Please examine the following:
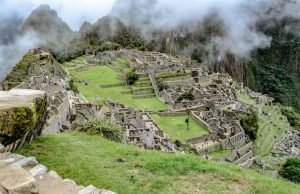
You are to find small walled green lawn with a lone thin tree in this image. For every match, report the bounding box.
[152,114,208,142]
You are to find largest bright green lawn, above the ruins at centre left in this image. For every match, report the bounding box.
[70,66,166,110]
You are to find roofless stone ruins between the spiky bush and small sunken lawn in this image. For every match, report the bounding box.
[105,99,175,152]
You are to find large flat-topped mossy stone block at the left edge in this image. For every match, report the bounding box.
[0,89,47,150]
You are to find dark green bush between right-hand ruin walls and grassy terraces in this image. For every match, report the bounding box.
[237,109,258,140]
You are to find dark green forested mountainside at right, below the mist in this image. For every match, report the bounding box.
[246,19,300,112]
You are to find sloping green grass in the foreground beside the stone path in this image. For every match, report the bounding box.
[18,132,300,194]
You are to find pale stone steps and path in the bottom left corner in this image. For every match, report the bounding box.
[0,150,115,194]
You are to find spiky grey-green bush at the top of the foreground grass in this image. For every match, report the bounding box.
[76,119,123,141]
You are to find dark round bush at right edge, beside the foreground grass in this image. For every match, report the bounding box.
[280,158,300,183]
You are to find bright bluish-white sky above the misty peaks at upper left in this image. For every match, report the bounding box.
[0,0,115,30]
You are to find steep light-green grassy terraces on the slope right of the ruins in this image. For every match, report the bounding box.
[237,91,290,156]
